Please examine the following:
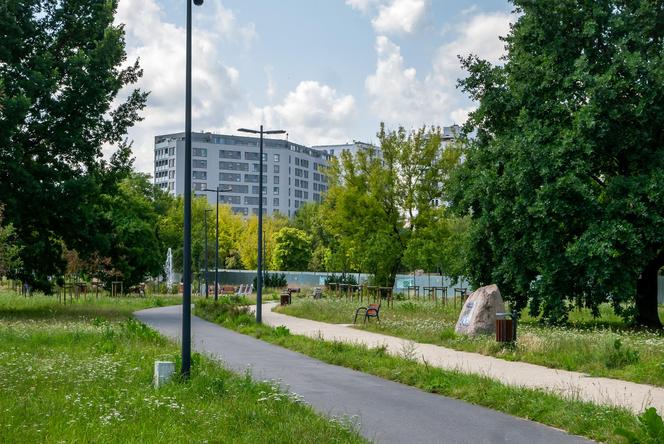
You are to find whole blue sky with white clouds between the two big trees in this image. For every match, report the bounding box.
[114,0,514,172]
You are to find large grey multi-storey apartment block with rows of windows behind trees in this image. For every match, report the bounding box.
[154,133,331,216]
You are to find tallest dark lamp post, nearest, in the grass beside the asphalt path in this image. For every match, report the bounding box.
[181,0,203,378]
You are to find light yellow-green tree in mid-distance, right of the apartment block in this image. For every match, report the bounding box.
[323,125,459,286]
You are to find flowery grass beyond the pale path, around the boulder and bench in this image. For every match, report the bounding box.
[276,298,664,386]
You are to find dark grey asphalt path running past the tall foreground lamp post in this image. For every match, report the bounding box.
[135,306,590,444]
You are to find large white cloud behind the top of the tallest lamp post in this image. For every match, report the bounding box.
[111,0,256,172]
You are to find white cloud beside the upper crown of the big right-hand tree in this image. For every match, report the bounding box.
[365,13,514,127]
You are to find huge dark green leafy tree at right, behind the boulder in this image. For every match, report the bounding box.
[452,0,664,328]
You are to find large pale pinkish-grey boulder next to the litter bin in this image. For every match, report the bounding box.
[454,284,505,336]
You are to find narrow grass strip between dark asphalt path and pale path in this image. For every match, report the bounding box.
[195,302,639,443]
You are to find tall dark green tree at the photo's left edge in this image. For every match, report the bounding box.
[0,0,146,290]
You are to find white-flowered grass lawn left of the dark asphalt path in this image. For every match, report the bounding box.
[0,293,365,443]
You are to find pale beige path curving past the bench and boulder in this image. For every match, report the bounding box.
[263,304,664,414]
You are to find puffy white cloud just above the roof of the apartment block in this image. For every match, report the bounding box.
[223,80,355,145]
